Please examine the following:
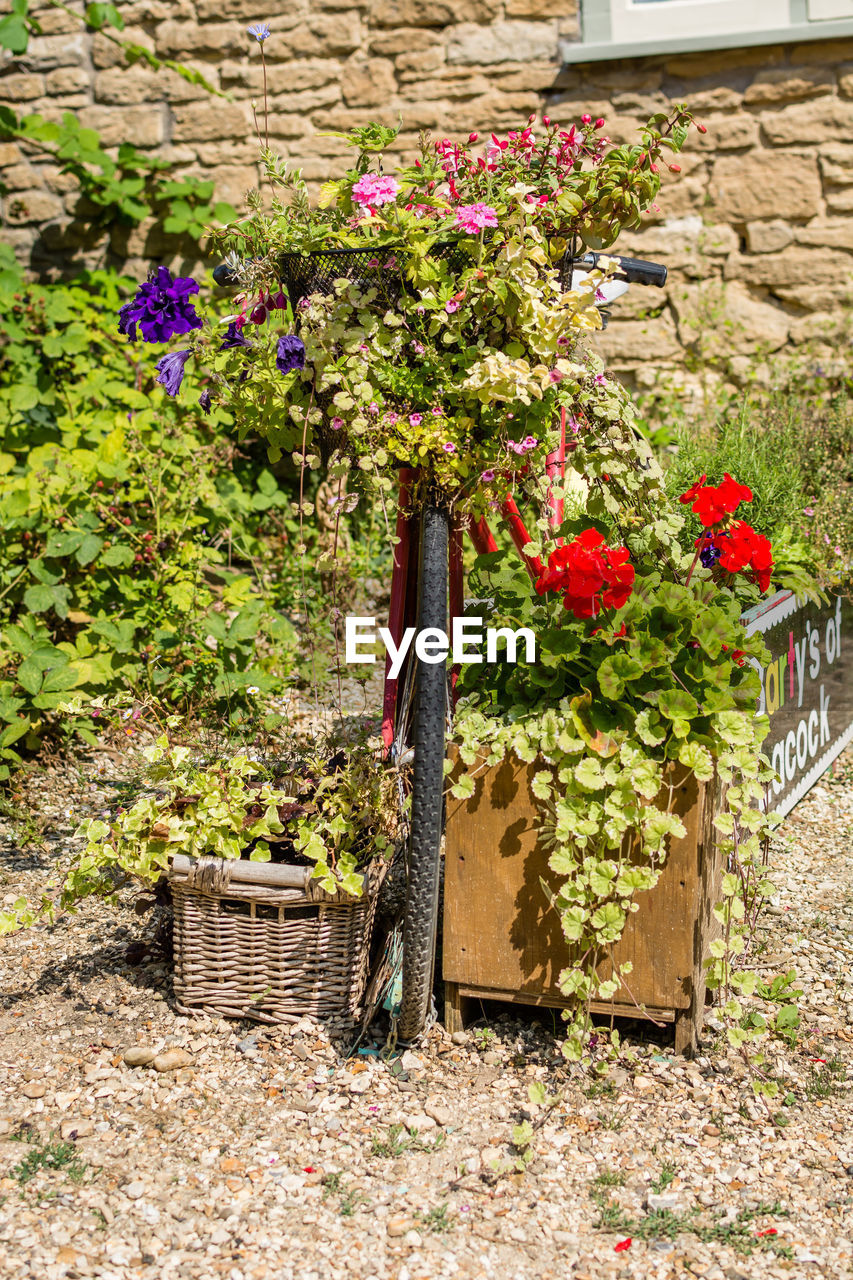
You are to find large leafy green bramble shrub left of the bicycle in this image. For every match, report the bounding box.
[0,245,297,778]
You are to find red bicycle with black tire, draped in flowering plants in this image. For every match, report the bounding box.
[213,243,667,1043]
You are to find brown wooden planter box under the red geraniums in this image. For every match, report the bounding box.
[443,759,720,1053]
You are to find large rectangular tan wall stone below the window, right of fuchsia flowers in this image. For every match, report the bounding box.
[710,152,821,223]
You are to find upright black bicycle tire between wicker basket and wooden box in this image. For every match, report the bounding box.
[397,503,450,1043]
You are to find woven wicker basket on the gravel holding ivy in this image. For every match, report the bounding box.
[169,856,386,1023]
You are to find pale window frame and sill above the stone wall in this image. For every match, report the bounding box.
[561,0,853,63]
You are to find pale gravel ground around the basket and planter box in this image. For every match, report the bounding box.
[0,753,853,1280]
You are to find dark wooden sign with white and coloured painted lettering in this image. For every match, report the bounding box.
[743,591,853,814]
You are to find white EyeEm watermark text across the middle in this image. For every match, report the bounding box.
[345,616,537,680]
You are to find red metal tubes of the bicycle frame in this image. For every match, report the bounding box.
[382,408,563,751]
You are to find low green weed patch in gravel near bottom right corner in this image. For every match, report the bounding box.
[590,1190,794,1258]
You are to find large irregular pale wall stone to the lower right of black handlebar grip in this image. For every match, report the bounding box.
[670,280,790,357]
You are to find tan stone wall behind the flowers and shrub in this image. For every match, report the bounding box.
[0,0,853,384]
